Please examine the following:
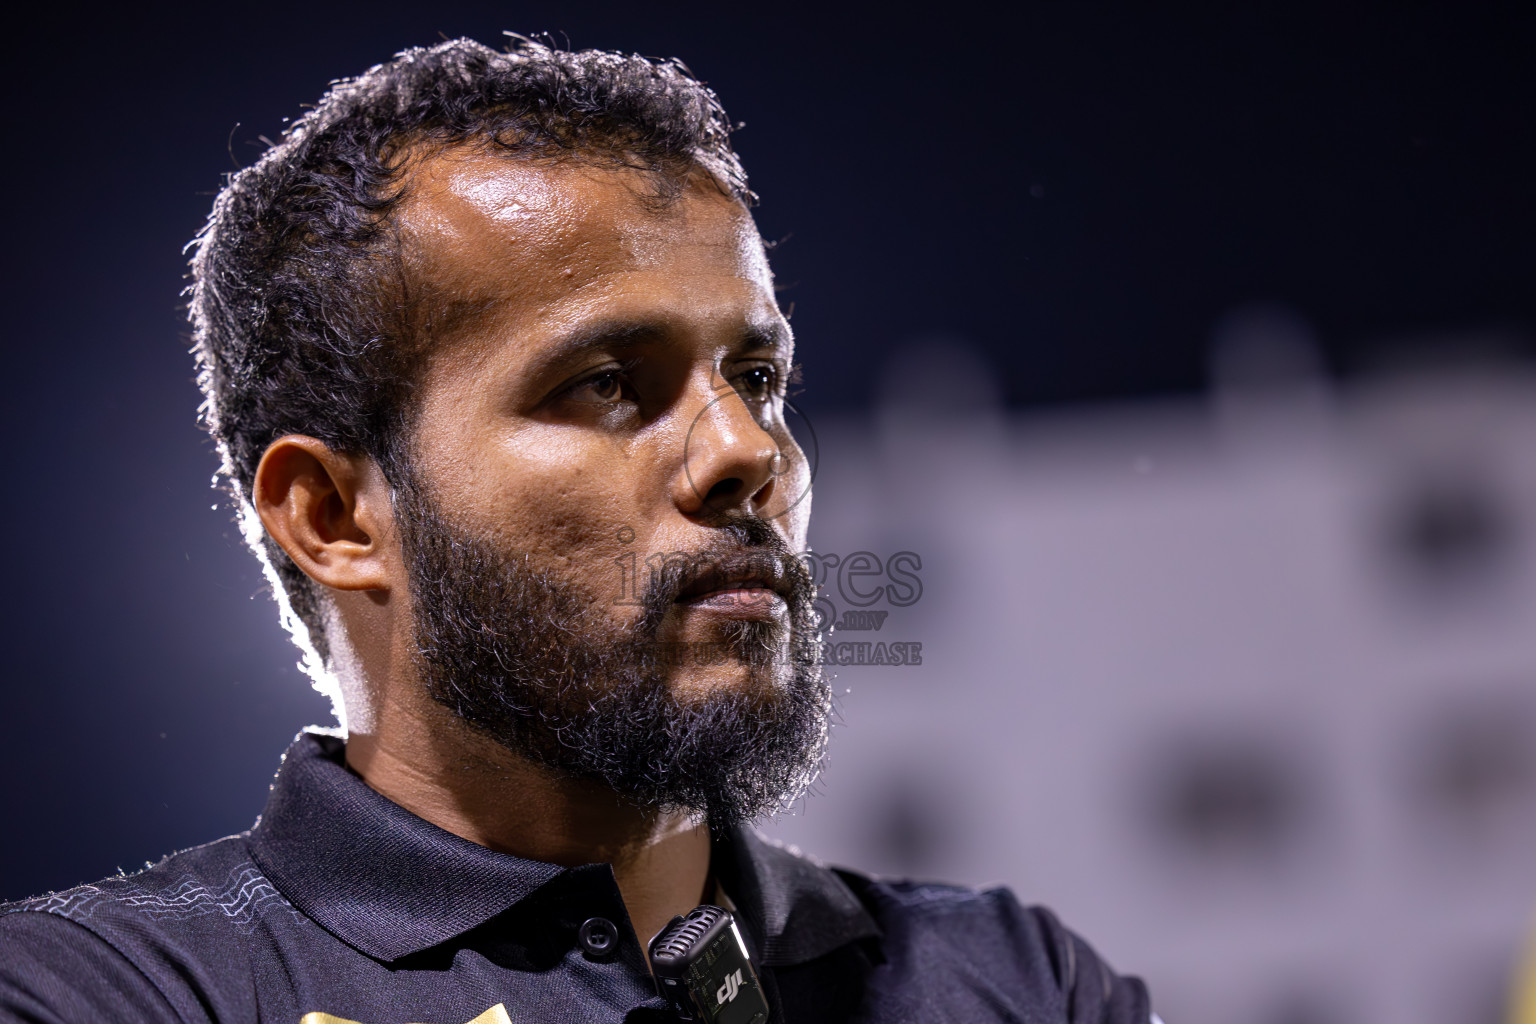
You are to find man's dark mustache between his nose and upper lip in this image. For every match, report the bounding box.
[634,514,816,640]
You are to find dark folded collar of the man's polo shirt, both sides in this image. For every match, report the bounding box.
[250,732,880,966]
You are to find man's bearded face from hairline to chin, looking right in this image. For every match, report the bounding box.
[396,150,826,818]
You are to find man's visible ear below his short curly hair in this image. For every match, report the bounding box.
[250,434,395,591]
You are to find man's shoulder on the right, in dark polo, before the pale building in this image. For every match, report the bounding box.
[837,869,1152,1024]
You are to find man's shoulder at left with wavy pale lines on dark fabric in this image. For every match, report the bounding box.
[0,835,293,1021]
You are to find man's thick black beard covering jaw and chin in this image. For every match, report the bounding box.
[396,484,833,829]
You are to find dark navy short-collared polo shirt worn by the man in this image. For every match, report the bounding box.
[0,734,1150,1024]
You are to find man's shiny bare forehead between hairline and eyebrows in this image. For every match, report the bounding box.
[396,147,773,340]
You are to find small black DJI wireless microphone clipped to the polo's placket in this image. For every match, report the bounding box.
[650,903,768,1024]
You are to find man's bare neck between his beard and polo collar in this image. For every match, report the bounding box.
[347,699,710,947]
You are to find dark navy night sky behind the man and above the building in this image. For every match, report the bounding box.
[0,0,1536,898]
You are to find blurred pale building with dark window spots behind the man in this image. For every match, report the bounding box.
[770,340,1536,1024]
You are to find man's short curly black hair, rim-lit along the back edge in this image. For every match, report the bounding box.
[189,34,754,697]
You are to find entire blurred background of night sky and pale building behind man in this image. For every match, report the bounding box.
[0,0,1536,1024]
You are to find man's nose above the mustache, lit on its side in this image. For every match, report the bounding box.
[673,380,791,516]
